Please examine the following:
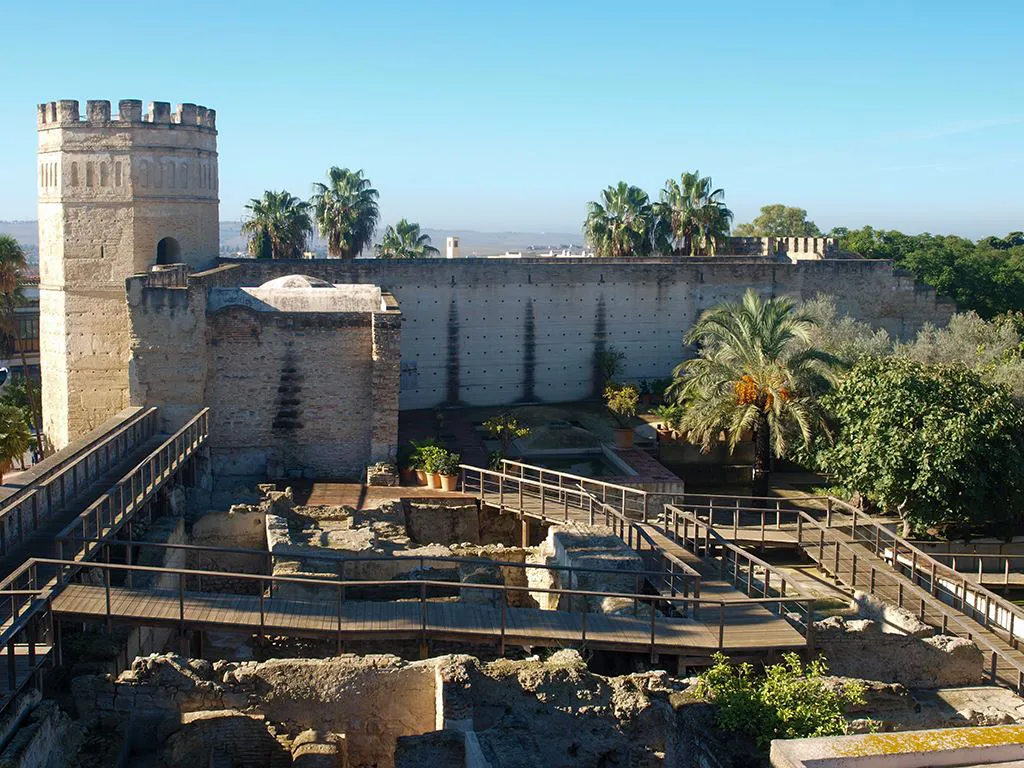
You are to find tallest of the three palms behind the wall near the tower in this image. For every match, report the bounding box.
[310,166,380,259]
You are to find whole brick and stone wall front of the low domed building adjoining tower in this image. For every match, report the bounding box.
[127,275,401,480]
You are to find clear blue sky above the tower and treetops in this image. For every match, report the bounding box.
[0,0,1024,237]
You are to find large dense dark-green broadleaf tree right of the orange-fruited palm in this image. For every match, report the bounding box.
[817,357,1024,534]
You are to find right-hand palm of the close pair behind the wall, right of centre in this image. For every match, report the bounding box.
[656,171,732,256]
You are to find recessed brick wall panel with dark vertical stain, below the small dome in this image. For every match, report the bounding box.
[206,307,374,478]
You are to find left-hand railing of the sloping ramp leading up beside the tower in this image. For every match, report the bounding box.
[0,408,159,556]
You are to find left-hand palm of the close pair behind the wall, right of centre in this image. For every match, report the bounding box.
[584,181,664,258]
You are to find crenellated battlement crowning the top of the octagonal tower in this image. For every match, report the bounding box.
[37,98,217,131]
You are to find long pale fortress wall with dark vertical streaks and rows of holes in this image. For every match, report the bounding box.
[209,257,954,410]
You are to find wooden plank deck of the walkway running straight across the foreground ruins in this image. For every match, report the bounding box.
[52,584,806,656]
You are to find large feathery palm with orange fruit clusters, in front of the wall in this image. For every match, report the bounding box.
[672,290,839,494]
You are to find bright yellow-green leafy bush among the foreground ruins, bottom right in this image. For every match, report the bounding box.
[697,653,864,751]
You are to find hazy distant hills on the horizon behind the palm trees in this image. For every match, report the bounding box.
[0,221,583,261]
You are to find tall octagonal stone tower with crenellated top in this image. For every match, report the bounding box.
[38,99,220,449]
